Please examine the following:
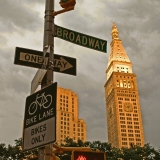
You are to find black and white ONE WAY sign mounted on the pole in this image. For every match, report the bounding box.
[14,47,76,75]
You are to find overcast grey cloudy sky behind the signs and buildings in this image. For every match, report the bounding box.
[0,0,160,148]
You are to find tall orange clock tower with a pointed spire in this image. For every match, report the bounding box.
[105,23,144,148]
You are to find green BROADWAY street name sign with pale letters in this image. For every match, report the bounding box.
[55,25,107,53]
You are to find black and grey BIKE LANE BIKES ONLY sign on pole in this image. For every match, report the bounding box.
[23,83,57,151]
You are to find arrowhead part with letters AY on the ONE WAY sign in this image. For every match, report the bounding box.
[54,57,73,72]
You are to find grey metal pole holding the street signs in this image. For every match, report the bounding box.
[38,0,54,160]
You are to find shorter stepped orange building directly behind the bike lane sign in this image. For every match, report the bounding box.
[56,87,86,144]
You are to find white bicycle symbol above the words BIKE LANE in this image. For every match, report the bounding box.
[28,92,52,115]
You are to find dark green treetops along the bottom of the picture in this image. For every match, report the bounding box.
[0,137,160,160]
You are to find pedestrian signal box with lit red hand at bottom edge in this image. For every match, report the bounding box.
[72,151,106,160]
